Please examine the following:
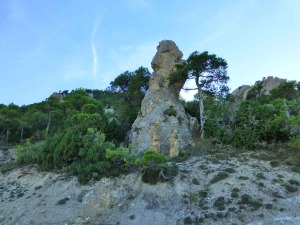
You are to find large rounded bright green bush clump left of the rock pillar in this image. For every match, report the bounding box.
[34,125,135,183]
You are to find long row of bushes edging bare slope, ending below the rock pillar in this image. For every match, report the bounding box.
[17,134,177,184]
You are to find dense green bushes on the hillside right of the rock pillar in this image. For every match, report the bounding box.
[183,81,300,149]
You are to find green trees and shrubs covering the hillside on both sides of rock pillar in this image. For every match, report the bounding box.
[0,67,300,183]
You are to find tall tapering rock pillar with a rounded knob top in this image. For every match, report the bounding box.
[129,40,198,157]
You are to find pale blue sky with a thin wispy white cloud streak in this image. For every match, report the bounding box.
[0,0,300,105]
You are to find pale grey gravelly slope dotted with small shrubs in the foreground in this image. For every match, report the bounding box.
[0,148,300,225]
